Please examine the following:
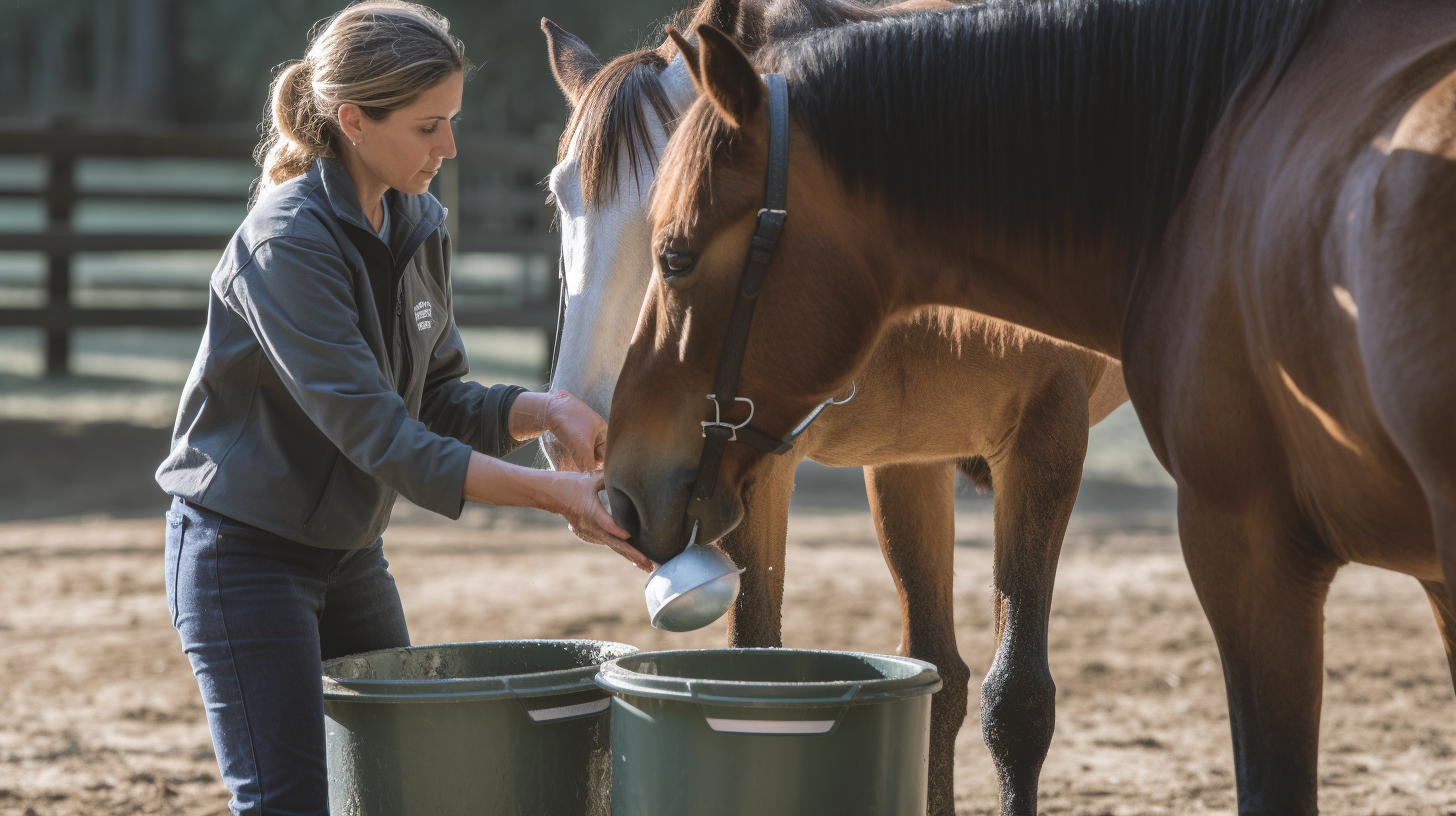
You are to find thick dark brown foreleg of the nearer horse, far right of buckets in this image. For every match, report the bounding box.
[1178,490,1340,816]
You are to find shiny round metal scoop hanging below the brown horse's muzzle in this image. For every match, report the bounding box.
[646,522,743,632]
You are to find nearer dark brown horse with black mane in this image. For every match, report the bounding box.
[607,0,1456,815]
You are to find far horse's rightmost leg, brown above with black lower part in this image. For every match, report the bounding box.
[981,408,1086,816]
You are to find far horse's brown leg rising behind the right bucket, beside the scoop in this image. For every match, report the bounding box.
[719,456,799,647]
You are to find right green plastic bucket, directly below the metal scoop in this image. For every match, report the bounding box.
[597,648,941,816]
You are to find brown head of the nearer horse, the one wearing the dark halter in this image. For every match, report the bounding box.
[607,26,885,561]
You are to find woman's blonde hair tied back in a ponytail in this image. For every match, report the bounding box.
[253,0,470,201]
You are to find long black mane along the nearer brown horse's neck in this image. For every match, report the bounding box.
[759,0,1326,246]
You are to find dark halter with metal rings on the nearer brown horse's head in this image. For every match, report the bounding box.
[693,74,855,501]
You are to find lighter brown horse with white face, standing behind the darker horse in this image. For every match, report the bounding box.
[546,0,1127,815]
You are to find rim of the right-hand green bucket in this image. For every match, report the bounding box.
[597,647,942,708]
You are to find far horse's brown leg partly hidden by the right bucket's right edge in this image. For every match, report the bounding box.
[865,462,971,816]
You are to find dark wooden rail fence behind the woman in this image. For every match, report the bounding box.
[0,127,559,376]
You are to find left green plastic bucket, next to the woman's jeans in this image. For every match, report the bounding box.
[323,640,636,816]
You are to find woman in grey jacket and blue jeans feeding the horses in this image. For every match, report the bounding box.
[157,0,649,815]
